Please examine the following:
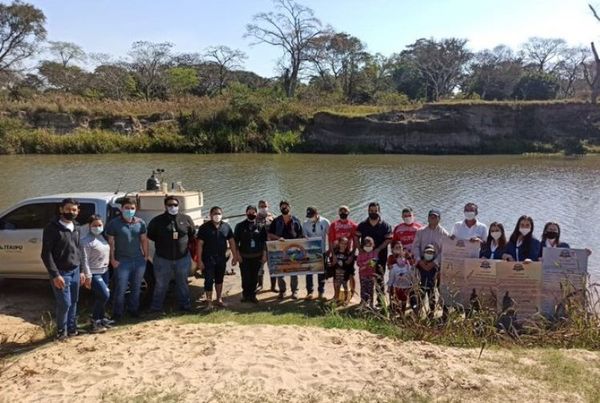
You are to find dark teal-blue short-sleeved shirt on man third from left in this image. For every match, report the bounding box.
[105,217,146,260]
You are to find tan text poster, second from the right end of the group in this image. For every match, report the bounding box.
[496,261,542,319]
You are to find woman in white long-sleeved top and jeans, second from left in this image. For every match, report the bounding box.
[81,215,112,333]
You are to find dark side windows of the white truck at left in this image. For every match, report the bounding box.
[0,203,96,230]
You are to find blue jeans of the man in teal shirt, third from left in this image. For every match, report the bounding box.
[113,257,146,319]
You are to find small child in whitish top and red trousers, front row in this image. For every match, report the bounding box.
[387,241,415,317]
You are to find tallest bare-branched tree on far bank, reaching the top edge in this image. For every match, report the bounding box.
[244,0,325,97]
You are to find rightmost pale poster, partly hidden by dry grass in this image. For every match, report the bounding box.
[541,248,588,317]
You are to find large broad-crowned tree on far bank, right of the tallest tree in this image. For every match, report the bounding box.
[401,38,472,101]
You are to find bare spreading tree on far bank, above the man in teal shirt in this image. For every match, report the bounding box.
[129,41,173,100]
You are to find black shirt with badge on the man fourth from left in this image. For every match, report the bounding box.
[148,213,196,260]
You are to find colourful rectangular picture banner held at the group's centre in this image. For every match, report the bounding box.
[267,237,325,277]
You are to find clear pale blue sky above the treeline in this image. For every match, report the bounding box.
[26,0,600,77]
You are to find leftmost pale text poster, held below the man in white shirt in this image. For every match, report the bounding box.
[440,238,479,305]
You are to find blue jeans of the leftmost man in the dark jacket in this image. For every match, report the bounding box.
[50,267,80,335]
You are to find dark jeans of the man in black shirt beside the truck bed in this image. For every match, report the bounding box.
[150,253,192,311]
